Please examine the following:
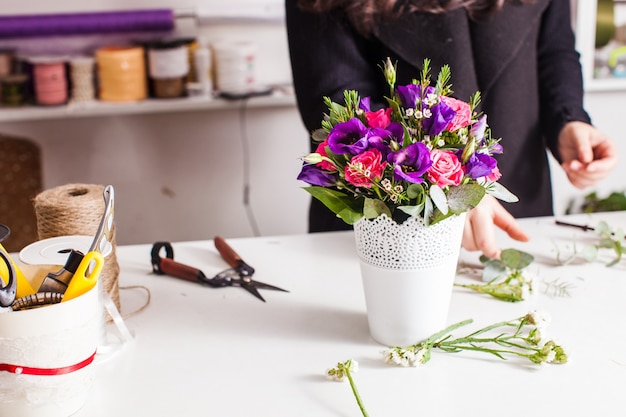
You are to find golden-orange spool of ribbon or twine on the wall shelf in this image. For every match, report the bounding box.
[96,46,147,102]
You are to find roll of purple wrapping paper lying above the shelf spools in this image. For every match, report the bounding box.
[0,9,174,39]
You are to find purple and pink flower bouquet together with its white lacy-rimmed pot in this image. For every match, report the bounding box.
[298,59,517,346]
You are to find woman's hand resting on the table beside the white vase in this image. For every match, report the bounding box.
[462,195,529,259]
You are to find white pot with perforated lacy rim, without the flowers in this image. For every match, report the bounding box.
[354,213,466,346]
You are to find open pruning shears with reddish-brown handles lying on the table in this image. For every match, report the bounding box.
[152,236,289,302]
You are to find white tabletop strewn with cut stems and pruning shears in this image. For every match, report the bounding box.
[77,212,626,417]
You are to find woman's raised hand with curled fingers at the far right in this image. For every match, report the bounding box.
[558,122,617,189]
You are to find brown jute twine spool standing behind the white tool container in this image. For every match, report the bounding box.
[34,184,121,310]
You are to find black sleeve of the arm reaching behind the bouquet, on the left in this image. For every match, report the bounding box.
[285,0,382,145]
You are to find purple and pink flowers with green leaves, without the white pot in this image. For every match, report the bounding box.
[298,58,517,225]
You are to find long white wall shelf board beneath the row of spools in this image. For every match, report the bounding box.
[0,93,296,123]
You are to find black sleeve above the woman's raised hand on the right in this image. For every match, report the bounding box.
[537,0,591,162]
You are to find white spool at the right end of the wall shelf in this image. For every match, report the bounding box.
[213,42,256,92]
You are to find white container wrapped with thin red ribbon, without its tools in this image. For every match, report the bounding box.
[0,276,104,417]
